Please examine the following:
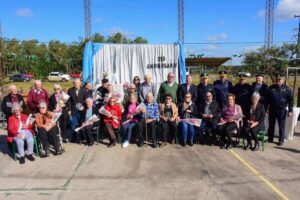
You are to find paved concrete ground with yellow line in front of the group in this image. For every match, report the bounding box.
[0,123,300,200]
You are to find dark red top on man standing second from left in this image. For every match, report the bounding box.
[27,88,49,112]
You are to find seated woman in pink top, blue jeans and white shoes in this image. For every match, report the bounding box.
[122,94,141,148]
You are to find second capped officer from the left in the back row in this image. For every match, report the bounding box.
[214,70,233,109]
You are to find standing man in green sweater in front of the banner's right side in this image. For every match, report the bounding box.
[157,72,178,104]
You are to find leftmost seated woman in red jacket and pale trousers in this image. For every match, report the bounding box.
[7,103,35,164]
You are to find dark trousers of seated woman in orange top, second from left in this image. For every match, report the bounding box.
[38,126,59,151]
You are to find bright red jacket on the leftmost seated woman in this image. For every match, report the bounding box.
[7,113,34,142]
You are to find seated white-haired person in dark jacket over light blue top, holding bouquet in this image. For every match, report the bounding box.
[81,98,99,146]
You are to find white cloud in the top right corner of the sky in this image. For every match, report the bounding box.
[275,0,300,21]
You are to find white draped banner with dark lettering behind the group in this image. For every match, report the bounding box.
[93,44,179,90]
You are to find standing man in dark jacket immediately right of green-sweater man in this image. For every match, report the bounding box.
[178,74,197,103]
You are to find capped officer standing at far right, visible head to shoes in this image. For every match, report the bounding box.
[267,74,294,146]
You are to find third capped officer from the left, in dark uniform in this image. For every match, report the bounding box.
[233,74,252,118]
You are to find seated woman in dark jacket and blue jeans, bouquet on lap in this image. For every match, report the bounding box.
[177,92,198,147]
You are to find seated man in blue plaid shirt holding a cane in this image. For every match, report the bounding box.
[138,92,159,148]
